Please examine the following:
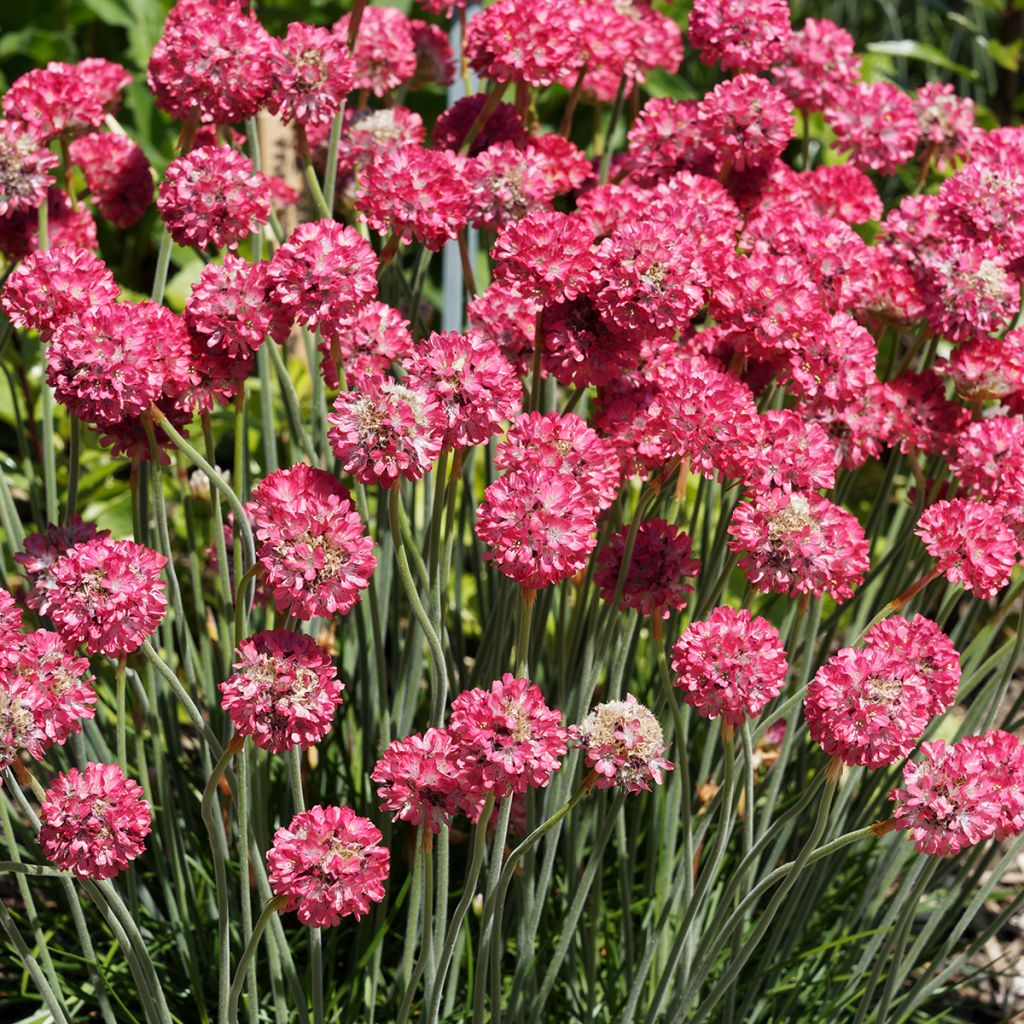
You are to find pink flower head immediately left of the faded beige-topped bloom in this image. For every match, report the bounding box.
[449,672,568,797]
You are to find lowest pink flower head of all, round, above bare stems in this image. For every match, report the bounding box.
[266,806,391,928]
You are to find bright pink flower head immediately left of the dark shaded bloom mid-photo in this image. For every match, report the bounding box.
[476,469,597,590]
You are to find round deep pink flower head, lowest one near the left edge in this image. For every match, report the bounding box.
[39,761,153,879]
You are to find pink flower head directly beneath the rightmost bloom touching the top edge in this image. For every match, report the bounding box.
[696,75,794,171]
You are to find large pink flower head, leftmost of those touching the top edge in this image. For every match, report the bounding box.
[146,2,274,125]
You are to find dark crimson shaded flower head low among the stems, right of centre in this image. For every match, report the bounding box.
[594,519,700,618]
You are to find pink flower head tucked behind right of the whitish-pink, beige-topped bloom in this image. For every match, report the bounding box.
[403,332,522,449]
